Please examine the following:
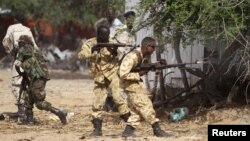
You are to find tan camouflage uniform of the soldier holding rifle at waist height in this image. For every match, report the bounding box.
[119,48,159,128]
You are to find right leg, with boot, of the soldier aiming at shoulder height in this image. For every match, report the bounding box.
[109,74,130,118]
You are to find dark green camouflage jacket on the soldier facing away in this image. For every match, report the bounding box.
[17,44,49,82]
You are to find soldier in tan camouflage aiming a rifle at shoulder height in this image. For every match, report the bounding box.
[78,25,130,136]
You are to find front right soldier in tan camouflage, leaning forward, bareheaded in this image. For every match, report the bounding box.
[119,37,169,137]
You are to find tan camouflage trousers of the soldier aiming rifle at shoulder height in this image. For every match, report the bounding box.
[92,73,130,119]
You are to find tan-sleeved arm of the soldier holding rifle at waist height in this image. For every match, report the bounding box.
[119,53,140,81]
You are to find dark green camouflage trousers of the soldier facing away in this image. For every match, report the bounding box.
[25,79,52,111]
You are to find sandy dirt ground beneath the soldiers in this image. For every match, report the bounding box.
[0,70,250,141]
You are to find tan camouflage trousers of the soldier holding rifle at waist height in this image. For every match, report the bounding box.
[123,81,159,128]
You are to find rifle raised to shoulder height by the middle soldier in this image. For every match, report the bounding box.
[91,43,139,52]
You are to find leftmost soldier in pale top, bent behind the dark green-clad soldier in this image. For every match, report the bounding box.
[2,15,38,117]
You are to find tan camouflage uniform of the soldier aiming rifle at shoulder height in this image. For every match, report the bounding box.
[78,38,129,119]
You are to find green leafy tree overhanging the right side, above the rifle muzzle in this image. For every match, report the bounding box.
[138,0,250,104]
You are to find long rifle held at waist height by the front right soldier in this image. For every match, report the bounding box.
[131,61,203,72]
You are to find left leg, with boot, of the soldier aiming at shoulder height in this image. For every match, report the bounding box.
[91,82,107,136]
